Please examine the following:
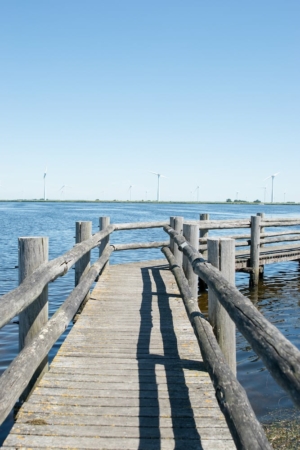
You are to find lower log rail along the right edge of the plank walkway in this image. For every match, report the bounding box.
[162,247,272,450]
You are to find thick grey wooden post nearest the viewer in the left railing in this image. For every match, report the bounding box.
[19,237,48,402]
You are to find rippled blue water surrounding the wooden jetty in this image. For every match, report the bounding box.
[0,202,300,445]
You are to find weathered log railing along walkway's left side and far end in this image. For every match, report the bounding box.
[0,217,168,424]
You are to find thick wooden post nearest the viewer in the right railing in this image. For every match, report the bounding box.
[207,238,236,374]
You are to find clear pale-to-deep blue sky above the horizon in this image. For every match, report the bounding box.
[0,0,300,201]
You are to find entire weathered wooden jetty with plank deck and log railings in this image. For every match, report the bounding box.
[0,214,300,450]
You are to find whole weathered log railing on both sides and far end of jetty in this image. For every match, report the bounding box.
[0,216,300,450]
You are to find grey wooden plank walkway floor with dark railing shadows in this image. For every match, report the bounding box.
[3,260,236,450]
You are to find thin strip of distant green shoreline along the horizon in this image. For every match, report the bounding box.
[0,199,300,206]
